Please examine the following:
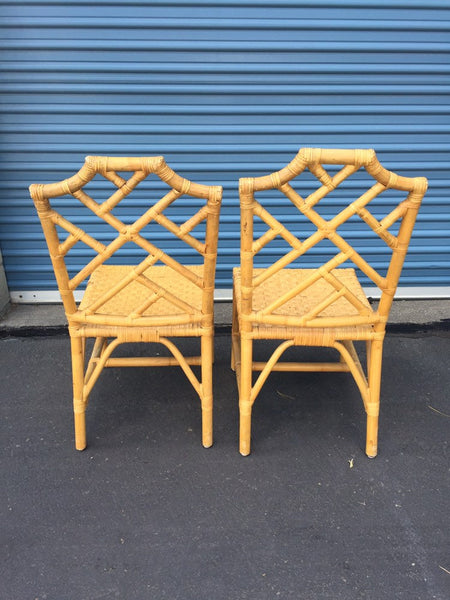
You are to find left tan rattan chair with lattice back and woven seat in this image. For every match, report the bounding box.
[30,156,222,450]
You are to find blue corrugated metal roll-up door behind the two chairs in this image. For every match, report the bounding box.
[0,0,450,300]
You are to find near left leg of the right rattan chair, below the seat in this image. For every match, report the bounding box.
[239,338,253,456]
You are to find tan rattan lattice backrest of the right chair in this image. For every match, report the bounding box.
[240,148,427,326]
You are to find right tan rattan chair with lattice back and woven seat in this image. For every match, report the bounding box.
[232,148,427,457]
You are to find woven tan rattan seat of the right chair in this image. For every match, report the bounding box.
[233,267,374,345]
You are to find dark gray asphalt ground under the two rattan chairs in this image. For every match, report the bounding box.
[0,332,450,600]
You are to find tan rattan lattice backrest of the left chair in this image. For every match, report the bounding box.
[30,156,222,324]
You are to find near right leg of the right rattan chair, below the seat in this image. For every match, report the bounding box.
[366,340,383,458]
